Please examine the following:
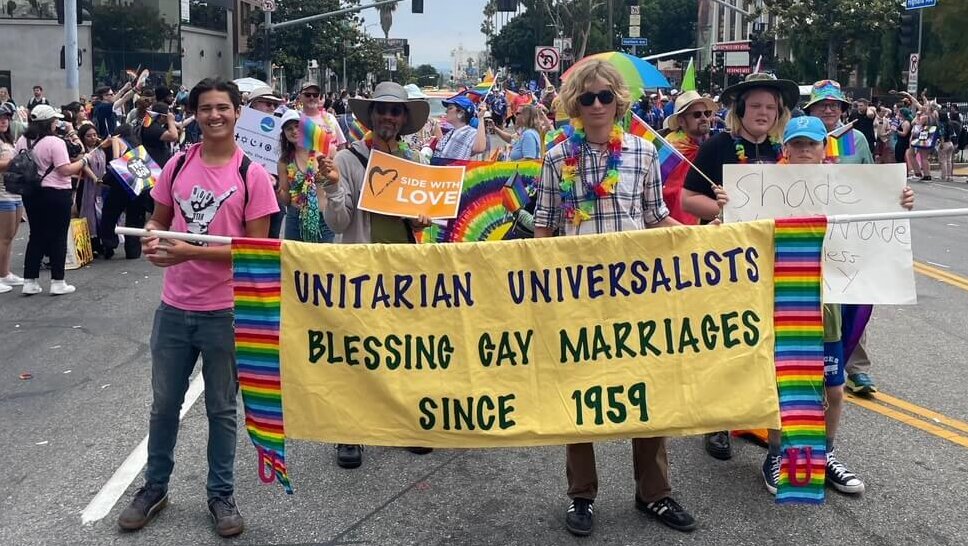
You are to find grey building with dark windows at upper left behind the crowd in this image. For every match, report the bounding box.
[0,0,241,105]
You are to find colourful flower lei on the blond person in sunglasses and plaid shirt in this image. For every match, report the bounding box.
[560,119,625,226]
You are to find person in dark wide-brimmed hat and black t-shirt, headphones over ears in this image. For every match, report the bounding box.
[682,73,800,460]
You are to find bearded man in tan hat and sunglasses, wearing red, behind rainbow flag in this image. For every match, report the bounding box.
[662,61,718,225]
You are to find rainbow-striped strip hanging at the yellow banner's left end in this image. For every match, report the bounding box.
[232,238,292,494]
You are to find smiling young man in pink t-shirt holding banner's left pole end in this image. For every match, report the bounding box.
[118,79,279,537]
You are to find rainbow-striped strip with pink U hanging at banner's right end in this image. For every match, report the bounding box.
[773,216,827,504]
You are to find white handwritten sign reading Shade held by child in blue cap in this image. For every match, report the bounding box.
[723,164,917,305]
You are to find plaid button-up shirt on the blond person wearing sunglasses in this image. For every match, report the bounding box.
[534,133,669,235]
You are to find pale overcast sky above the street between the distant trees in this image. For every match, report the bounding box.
[363,0,485,69]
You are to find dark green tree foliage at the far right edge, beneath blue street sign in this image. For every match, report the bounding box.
[919,2,968,97]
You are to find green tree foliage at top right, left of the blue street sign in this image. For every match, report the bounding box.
[763,0,901,79]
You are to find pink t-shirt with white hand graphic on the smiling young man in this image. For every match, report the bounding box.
[151,144,279,311]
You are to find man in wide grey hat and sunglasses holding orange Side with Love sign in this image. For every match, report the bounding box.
[323,82,431,468]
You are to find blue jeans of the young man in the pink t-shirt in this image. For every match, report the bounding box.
[145,303,239,498]
